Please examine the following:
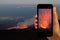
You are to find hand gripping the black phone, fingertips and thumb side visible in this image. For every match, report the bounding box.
[34,7,60,40]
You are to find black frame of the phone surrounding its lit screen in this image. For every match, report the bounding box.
[37,4,53,36]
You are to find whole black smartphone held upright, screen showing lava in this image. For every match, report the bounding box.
[37,4,53,36]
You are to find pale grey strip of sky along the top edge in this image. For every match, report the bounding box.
[0,0,60,4]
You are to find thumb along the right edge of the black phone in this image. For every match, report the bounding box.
[53,7,59,34]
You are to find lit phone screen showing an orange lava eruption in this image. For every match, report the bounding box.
[38,9,52,30]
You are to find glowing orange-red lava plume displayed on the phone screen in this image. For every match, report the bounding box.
[39,10,51,29]
